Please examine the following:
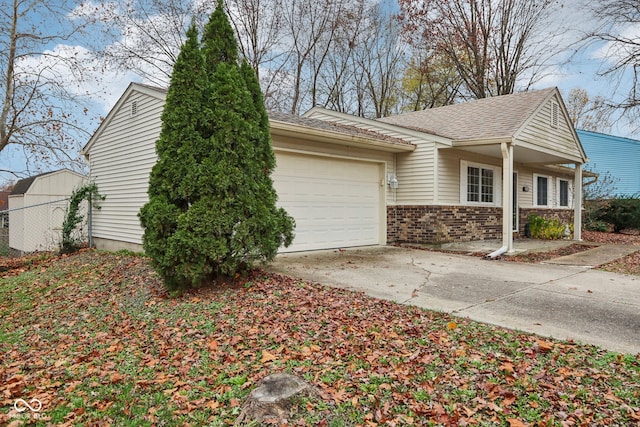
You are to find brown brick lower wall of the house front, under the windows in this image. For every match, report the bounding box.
[387,205,573,244]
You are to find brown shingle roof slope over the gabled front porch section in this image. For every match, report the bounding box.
[378,88,556,140]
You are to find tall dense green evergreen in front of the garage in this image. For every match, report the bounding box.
[140,1,293,290]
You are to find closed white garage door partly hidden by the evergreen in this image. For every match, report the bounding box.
[273,152,382,252]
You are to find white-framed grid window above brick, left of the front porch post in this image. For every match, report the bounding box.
[460,161,500,205]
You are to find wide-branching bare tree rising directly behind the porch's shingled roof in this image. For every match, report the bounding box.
[399,0,556,98]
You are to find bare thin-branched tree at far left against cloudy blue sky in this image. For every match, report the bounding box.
[0,0,95,177]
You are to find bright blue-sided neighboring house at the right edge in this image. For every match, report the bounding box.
[576,130,640,196]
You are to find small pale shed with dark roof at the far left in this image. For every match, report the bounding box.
[9,169,87,253]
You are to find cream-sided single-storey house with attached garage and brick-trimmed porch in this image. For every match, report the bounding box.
[83,83,587,251]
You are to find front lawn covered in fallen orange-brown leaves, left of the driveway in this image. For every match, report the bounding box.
[0,251,640,426]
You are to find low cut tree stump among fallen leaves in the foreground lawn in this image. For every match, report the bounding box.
[234,374,320,426]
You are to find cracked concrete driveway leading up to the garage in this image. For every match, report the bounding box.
[268,246,640,354]
